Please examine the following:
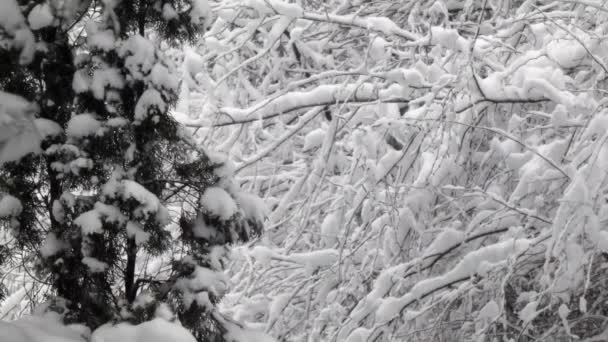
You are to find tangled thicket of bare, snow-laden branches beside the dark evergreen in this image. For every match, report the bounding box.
[181,0,608,341]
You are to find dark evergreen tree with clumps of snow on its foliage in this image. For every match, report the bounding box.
[0,0,262,341]
